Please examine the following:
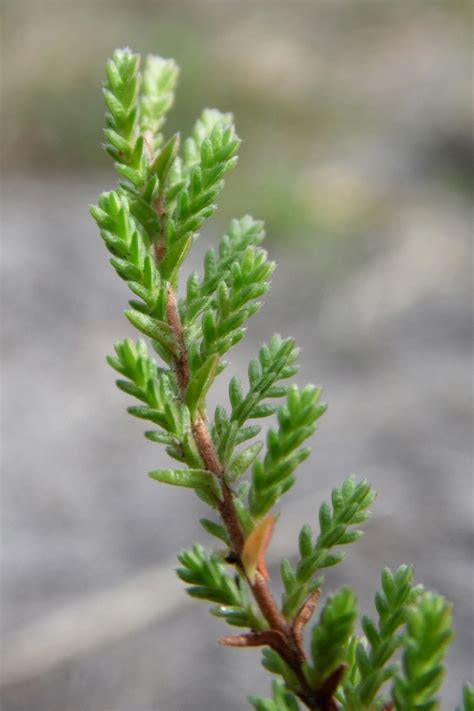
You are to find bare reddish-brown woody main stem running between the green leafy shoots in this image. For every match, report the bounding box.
[167,286,326,711]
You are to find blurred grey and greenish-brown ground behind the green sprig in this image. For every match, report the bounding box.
[1,0,474,711]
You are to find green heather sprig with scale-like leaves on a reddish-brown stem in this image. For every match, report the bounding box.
[91,49,474,711]
